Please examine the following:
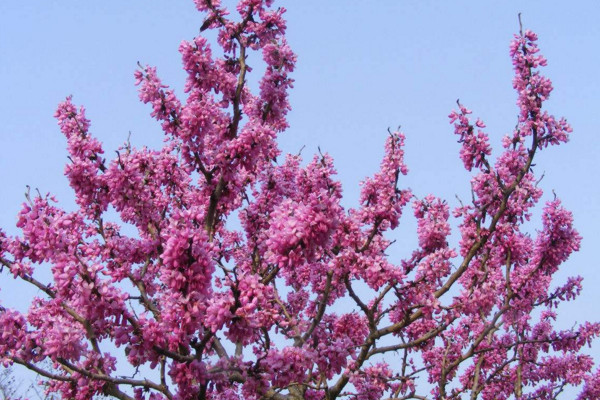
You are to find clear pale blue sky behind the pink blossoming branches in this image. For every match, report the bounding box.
[0,0,600,396]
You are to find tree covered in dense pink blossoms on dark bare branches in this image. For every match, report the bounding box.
[0,0,600,400]
